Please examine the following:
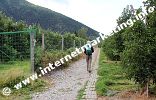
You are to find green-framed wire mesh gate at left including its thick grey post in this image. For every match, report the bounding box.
[0,31,35,71]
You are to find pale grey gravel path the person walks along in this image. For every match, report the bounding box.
[32,49,99,100]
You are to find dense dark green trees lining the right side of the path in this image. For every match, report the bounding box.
[102,0,156,90]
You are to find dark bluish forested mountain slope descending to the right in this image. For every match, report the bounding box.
[0,0,97,36]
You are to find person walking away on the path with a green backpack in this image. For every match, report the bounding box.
[84,41,94,73]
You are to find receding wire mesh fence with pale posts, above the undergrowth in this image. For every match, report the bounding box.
[40,33,86,51]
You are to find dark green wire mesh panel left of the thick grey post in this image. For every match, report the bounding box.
[0,33,30,63]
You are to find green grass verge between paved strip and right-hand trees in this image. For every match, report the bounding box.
[96,50,137,96]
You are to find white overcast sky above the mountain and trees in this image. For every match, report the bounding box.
[27,0,143,34]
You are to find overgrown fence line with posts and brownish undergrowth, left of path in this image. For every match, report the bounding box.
[35,31,87,71]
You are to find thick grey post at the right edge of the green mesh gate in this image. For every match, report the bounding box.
[30,31,35,73]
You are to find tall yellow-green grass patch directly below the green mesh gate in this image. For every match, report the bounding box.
[0,61,30,87]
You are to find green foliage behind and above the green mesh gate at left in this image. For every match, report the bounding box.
[0,12,30,62]
